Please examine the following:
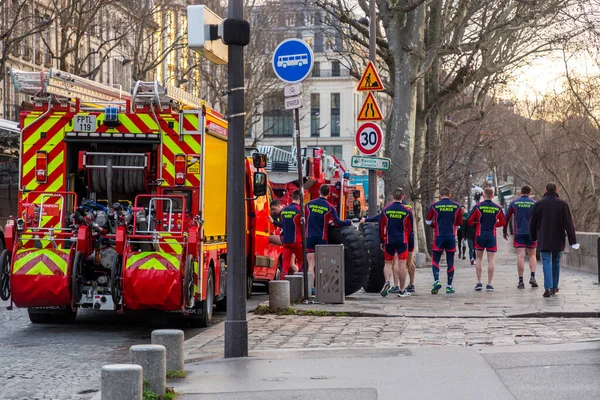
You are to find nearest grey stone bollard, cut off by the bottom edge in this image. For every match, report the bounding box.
[100,364,144,400]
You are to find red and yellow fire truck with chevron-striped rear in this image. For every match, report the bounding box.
[0,70,278,326]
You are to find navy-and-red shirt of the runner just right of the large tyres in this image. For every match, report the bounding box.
[365,201,414,244]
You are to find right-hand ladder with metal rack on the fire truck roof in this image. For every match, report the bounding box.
[131,81,202,112]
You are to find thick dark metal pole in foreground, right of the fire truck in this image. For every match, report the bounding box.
[225,0,248,358]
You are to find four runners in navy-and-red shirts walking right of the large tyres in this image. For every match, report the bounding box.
[360,186,538,297]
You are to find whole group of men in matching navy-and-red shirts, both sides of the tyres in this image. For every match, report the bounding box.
[271,185,538,297]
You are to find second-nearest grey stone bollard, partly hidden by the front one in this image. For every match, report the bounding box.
[129,344,167,396]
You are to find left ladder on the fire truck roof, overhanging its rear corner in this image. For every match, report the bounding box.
[9,68,131,103]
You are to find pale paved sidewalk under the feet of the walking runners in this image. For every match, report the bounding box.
[292,238,600,318]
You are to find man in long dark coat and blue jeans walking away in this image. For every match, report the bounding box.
[529,182,579,297]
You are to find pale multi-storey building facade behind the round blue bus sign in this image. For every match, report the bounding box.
[246,0,363,170]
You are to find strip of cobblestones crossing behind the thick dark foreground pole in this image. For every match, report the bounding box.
[186,315,600,362]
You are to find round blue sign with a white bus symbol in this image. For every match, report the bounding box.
[273,39,315,83]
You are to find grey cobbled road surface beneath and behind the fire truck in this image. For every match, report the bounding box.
[0,286,266,400]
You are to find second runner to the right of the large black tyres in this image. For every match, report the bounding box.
[425,188,462,294]
